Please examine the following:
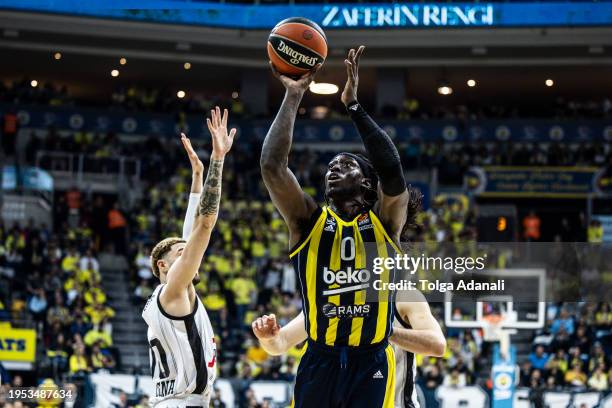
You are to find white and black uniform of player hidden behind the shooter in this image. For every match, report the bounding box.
[392,308,419,408]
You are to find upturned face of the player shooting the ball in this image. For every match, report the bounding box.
[325,155,364,199]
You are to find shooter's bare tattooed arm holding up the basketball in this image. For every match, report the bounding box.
[260,64,320,246]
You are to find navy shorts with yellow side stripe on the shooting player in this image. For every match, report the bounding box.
[292,341,395,408]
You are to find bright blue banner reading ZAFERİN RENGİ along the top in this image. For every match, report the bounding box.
[0,0,612,29]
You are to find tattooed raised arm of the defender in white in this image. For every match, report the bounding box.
[162,107,236,299]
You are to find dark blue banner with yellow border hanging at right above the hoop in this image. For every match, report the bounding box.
[465,166,612,198]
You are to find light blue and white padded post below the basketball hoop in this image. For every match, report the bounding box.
[491,344,516,408]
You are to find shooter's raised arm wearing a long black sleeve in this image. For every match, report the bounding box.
[341,45,410,242]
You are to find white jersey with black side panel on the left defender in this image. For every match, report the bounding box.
[142,284,217,405]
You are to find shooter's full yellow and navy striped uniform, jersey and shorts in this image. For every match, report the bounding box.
[290,207,400,408]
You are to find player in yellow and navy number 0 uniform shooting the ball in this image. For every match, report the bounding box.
[261,46,418,408]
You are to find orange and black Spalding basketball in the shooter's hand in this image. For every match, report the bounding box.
[268,17,327,77]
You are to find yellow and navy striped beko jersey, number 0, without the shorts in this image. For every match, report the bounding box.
[290,207,399,347]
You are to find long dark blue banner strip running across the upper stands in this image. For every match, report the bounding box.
[0,105,612,143]
